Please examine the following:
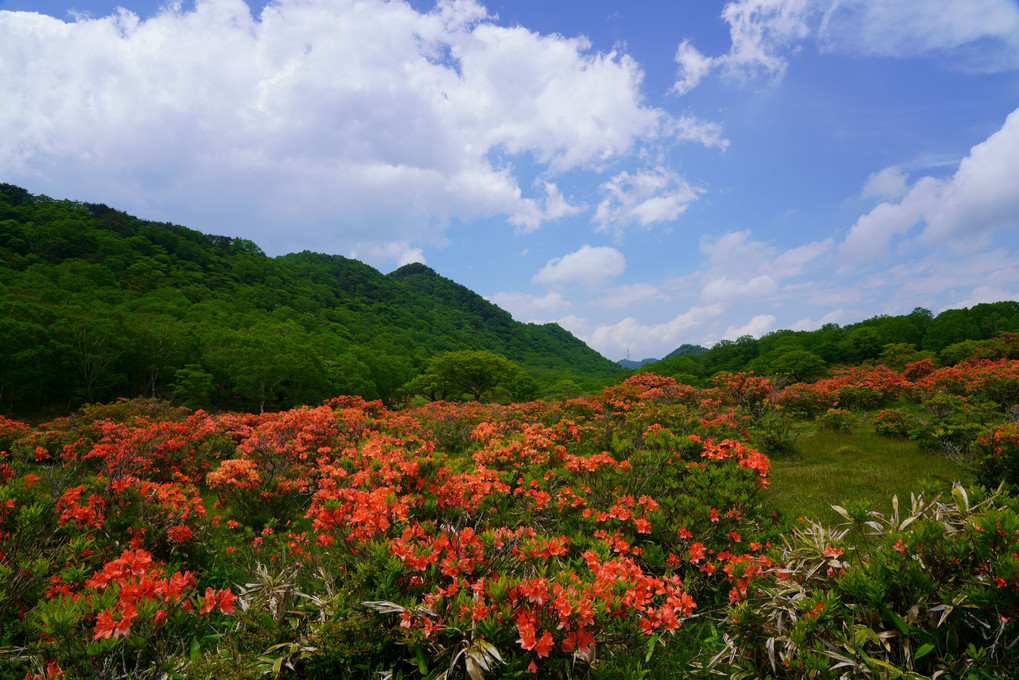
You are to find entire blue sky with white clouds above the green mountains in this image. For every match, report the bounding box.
[0,0,1019,360]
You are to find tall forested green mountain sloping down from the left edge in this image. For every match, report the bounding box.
[0,185,623,412]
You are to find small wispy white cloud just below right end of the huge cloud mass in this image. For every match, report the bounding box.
[594,167,703,233]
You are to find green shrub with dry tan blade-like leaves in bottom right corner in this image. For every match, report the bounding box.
[702,486,1019,680]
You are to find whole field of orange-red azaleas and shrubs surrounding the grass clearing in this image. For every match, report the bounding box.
[0,357,1019,680]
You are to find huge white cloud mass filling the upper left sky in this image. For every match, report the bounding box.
[0,0,723,263]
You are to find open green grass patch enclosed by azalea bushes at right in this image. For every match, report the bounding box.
[765,426,970,524]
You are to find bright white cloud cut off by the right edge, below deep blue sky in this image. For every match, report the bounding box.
[840,109,1019,262]
